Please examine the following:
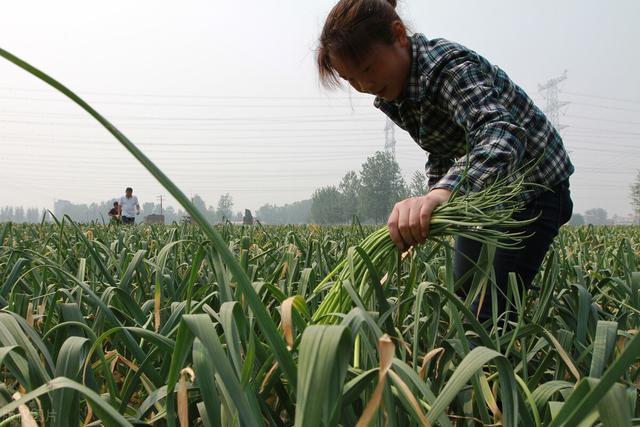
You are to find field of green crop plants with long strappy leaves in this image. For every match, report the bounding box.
[0,44,640,427]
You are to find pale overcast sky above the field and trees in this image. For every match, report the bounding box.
[0,0,640,219]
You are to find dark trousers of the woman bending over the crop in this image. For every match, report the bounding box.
[454,180,573,322]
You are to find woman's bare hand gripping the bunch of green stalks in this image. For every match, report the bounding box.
[387,188,451,250]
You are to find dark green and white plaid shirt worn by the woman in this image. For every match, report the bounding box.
[374,34,574,200]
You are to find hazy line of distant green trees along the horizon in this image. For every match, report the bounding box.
[0,158,640,225]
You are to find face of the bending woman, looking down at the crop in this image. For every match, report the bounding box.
[330,24,411,101]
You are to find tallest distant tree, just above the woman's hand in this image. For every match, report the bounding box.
[360,151,407,222]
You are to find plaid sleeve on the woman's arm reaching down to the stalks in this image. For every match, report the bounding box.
[430,55,526,191]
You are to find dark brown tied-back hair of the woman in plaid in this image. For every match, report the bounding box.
[317,0,402,86]
